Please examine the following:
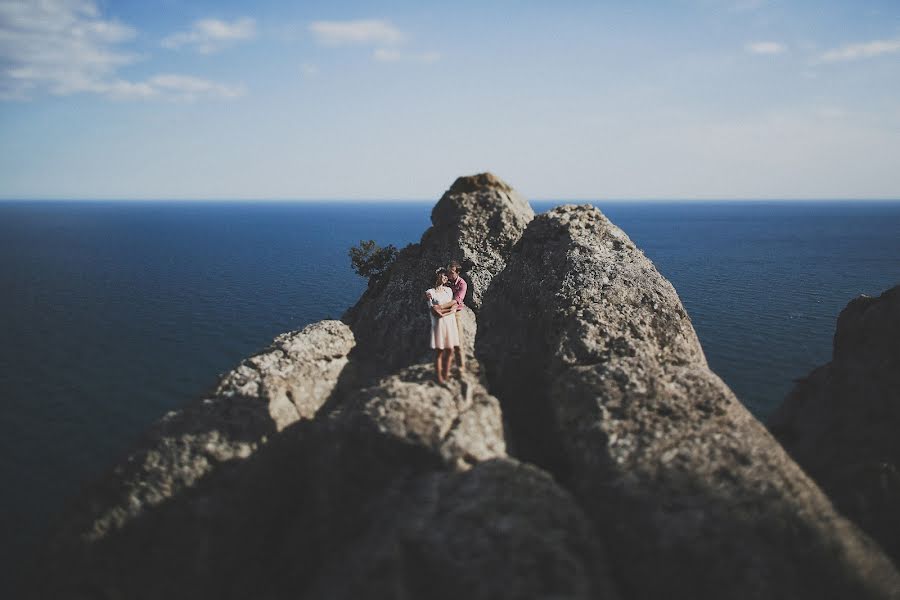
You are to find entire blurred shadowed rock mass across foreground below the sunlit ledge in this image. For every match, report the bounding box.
[40,408,618,600]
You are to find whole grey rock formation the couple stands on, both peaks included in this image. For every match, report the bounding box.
[35,174,900,599]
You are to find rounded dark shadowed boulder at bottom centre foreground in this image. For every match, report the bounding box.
[310,459,619,600]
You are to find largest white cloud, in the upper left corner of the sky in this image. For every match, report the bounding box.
[0,0,244,101]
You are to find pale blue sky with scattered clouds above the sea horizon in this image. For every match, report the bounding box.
[0,0,900,200]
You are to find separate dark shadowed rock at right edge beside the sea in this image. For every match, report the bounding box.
[769,286,900,564]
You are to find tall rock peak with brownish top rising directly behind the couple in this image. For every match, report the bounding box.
[343,173,534,374]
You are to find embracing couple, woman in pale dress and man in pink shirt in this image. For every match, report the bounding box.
[425,260,467,383]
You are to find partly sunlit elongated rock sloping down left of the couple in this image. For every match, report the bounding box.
[40,321,354,551]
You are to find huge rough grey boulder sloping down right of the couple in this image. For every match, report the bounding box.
[476,206,900,598]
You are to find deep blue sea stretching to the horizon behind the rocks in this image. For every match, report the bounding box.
[0,201,900,595]
